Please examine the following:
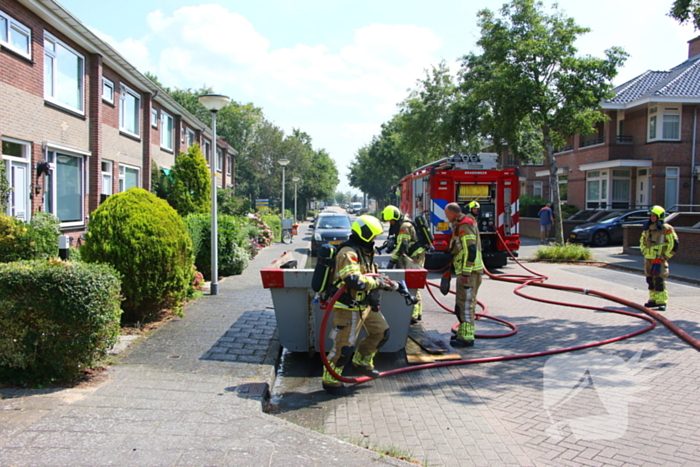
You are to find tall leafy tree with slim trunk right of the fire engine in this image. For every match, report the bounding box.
[462,0,627,244]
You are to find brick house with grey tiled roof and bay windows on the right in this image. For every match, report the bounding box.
[521,37,700,210]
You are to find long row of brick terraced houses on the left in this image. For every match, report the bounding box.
[0,0,235,238]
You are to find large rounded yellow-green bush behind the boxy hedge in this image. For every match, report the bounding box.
[81,188,193,323]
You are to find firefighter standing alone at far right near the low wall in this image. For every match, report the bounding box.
[639,206,679,311]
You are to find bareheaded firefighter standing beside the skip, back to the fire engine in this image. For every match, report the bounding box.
[445,201,484,347]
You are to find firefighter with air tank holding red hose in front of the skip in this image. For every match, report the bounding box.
[323,215,399,395]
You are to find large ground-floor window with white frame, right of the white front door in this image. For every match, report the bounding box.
[44,151,85,226]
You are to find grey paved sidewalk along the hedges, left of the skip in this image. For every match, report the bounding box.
[0,221,410,467]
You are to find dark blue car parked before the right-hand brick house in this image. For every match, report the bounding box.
[569,210,649,246]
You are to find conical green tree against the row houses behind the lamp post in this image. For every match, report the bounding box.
[167,144,211,217]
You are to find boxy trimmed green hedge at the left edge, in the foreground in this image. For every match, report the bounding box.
[0,260,121,384]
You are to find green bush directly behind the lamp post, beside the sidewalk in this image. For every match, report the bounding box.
[195,216,250,280]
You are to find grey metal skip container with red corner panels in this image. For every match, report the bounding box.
[260,263,428,353]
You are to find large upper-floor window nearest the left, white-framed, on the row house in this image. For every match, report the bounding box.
[44,32,85,113]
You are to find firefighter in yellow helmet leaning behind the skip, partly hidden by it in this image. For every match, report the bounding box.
[382,205,425,324]
